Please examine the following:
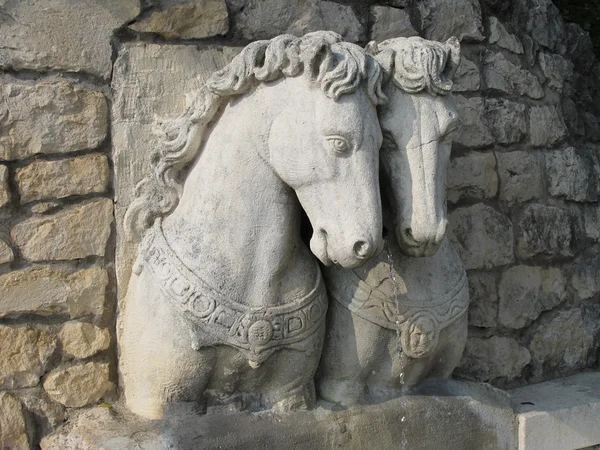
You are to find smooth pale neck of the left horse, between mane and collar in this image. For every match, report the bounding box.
[159,86,317,306]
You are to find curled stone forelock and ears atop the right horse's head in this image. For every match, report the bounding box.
[367,37,460,95]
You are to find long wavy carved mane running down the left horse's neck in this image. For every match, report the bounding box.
[124,31,387,240]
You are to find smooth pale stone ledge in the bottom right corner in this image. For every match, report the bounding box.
[510,372,600,450]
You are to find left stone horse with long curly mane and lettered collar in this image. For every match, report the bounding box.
[120,32,385,419]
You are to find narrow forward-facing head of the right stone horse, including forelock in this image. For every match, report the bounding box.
[368,37,460,256]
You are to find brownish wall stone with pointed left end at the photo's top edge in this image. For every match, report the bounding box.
[130,0,229,39]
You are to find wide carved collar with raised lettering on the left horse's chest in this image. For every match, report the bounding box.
[133,220,327,366]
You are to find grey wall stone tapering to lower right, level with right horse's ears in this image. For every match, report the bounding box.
[483,51,544,99]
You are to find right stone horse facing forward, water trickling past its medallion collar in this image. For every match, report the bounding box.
[317,37,469,405]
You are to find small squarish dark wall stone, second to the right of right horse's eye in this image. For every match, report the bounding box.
[485,98,527,144]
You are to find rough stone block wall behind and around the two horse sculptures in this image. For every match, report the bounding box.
[0,0,600,449]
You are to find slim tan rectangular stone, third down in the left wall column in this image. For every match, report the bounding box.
[15,155,110,203]
